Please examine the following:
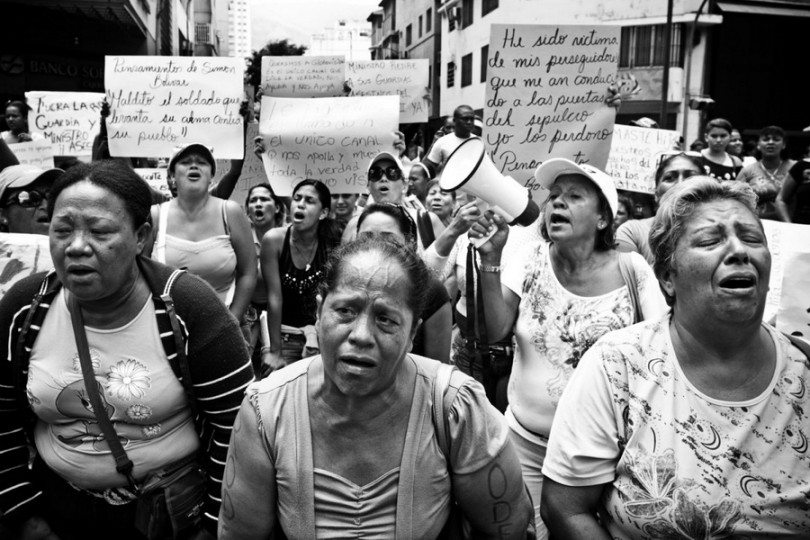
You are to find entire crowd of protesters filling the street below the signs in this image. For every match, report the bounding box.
[0,91,810,540]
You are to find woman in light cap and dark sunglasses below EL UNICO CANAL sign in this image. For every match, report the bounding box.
[342,152,444,254]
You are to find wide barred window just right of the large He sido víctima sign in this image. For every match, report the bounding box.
[619,24,684,68]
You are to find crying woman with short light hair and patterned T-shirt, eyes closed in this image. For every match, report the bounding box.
[542,177,810,540]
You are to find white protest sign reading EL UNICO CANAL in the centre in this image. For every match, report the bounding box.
[259,96,399,197]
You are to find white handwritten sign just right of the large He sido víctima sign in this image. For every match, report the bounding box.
[605,124,680,194]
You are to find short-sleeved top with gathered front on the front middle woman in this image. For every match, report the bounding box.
[246,355,509,540]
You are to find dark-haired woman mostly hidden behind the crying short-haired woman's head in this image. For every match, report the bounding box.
[616,152,703,266]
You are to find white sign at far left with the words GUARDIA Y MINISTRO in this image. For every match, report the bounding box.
[25,92,104,158]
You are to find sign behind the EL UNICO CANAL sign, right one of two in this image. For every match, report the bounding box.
[346,58,430,124]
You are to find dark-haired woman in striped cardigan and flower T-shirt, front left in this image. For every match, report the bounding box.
[0,162,253,540]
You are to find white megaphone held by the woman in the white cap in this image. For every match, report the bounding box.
[439,137,540,238]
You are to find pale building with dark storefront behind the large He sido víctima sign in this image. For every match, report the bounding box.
[438,0,810,147]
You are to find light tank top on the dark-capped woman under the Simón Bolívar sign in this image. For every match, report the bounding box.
[152,201,236,306]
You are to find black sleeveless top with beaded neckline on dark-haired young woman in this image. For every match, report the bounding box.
[278,227,329,328]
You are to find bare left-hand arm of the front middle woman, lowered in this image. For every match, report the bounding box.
[217,397,278,540]
